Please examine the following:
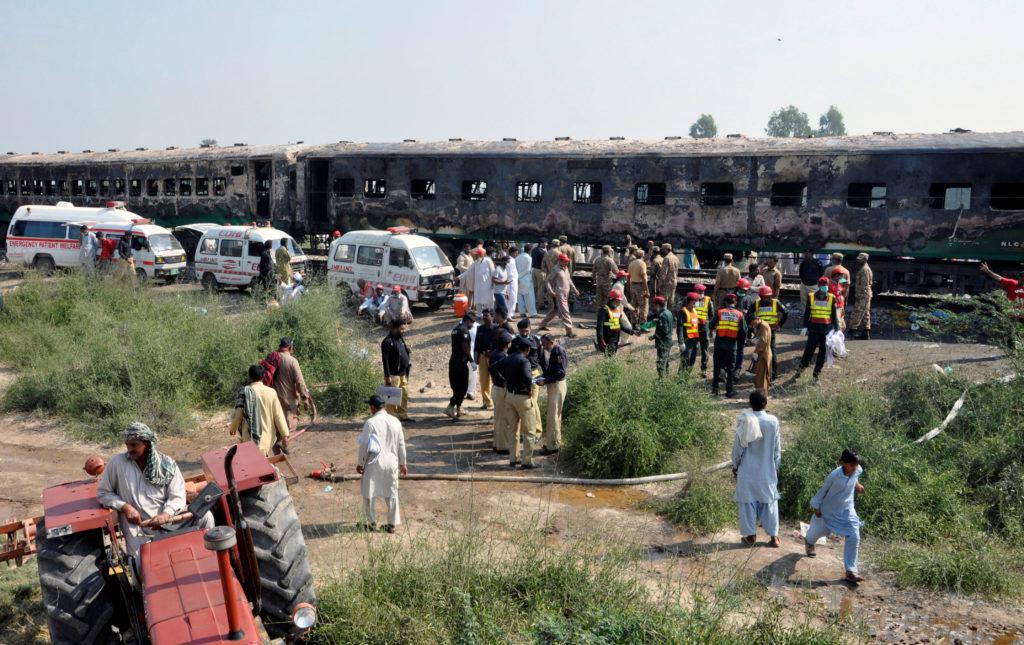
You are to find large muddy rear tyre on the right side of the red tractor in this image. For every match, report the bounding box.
[241,481,316,637]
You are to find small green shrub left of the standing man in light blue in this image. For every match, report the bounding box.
[656,467,737,535]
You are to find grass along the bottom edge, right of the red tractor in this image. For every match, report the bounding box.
[312,531,856,645]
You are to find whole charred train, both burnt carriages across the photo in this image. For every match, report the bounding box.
[0,132,1024,291]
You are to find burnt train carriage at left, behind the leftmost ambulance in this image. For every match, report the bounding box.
[0,144,297,230]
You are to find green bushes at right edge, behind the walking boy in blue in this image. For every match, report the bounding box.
[779,372,1024,595]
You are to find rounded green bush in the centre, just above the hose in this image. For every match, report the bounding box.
[562,356,725,477]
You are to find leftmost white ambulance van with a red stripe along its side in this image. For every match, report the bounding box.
[7,202,185,282]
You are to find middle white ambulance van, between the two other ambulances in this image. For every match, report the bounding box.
[196,226,306,289]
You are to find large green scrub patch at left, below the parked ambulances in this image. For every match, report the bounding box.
[0,272,379,439]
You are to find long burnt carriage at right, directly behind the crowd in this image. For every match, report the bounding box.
[298,132,1024,291]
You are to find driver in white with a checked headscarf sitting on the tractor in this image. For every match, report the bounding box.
[96,421,213,560]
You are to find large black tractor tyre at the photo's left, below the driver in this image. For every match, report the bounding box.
[36,524,117,645]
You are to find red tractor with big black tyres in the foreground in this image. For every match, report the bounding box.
[0,442,316,645]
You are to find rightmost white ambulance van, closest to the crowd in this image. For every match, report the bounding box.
[327,226,455,309]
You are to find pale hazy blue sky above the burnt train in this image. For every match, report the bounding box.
[0,0,1024,153]
